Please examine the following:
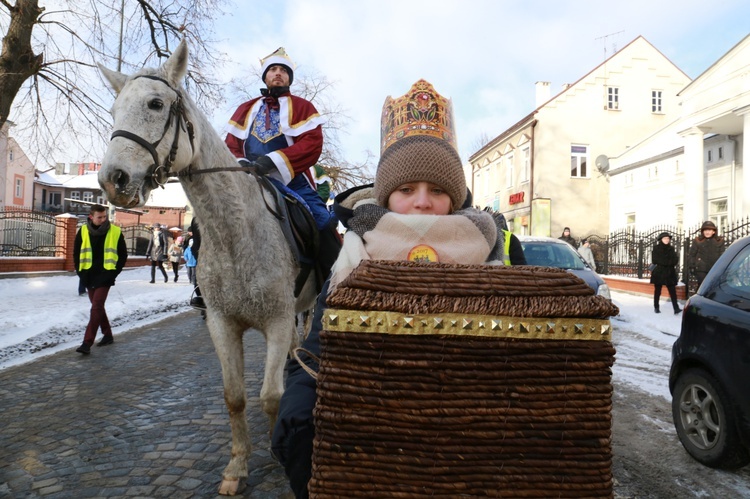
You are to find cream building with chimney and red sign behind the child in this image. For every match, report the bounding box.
[468,36,690,238]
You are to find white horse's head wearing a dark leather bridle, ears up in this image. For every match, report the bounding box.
[99,40,194,207]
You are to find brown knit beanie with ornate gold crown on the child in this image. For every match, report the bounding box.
[374,80,467,210]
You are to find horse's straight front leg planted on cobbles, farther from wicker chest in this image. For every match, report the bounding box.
[206,308,251,496]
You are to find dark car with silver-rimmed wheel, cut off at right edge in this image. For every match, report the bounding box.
[669,237,750,469]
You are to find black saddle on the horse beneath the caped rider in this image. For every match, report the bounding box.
[255,175,327,298]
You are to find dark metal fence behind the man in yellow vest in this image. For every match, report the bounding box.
[0,210,151,257]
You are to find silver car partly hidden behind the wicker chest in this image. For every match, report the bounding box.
[518,236,612,299]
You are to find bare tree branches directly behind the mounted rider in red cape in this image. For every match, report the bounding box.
[227,67,374,192]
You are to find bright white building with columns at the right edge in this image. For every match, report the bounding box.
[609,35,750,230]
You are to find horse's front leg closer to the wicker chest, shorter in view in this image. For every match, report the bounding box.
[260,312,295,431]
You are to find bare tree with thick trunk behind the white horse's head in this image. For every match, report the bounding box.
[0,0,224,162]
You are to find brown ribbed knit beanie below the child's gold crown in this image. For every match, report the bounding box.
[374,135,466,210]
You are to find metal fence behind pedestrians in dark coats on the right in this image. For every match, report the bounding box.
[586,217,750,294]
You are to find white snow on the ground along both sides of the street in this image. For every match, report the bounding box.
[0,267,682,400]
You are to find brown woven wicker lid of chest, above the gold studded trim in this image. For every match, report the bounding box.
[327,260,619,318]
